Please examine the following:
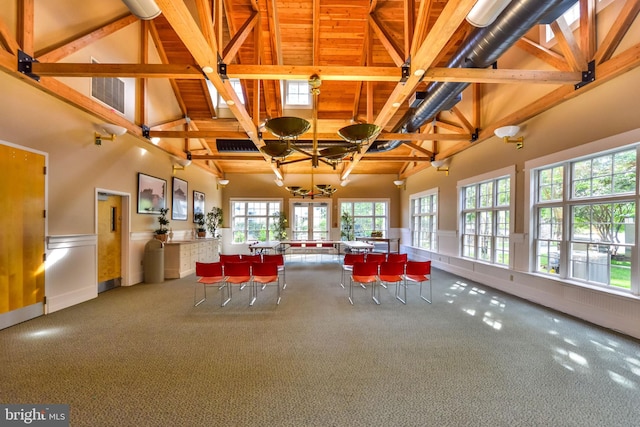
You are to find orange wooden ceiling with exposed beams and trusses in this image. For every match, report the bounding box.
[0,0,640,178]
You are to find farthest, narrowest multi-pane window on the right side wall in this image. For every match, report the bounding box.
[411,192,438,251]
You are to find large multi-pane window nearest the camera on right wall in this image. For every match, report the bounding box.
[534,148,638,290]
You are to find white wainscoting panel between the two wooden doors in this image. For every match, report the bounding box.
[45,234,98,313]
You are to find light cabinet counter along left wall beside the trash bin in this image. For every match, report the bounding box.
[164,239,218,279]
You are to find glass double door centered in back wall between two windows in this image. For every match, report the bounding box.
[291,201,331,240]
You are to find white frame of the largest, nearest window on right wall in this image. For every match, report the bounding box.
[531,148,640,292]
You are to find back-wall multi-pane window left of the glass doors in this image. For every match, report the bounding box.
[231,200,282,243]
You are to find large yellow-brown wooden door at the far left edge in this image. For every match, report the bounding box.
[0,144,46,320]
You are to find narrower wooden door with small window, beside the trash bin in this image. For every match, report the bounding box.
[98,194,122,292]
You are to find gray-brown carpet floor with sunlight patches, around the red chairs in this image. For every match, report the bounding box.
[0,262,640,427]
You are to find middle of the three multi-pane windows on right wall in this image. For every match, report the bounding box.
[461,176,511,265]
